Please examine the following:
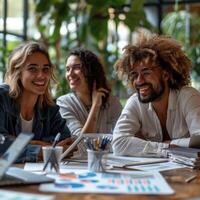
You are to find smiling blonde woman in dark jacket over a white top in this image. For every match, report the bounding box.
[0,42,70,161]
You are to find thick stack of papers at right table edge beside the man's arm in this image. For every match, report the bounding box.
[169,147,200,169]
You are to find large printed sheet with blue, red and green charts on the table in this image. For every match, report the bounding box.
[39,169,174,195]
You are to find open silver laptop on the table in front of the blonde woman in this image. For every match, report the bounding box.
[0,133,54,186]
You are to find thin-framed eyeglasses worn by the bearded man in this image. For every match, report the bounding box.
[128,66,159,81]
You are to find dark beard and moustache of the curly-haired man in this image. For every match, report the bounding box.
[136,80,165,103]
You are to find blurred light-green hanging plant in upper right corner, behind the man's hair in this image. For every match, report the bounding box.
[162,4,200,85]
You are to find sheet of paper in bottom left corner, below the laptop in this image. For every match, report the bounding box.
[0,190,54,200]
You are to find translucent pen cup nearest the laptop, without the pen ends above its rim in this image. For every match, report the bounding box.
[42,146,63,172]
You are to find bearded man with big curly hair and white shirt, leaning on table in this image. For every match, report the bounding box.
[113,30,200,155]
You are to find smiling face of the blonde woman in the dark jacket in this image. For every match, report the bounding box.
[20,52,52,96]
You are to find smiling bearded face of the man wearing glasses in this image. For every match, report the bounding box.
[130,59,168,103]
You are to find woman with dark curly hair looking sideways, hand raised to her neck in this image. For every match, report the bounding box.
[57,48,121,155]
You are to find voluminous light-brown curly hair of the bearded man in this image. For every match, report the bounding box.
[115,35,191,89]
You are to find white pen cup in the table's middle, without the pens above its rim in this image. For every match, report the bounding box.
[87,149,108,172]
